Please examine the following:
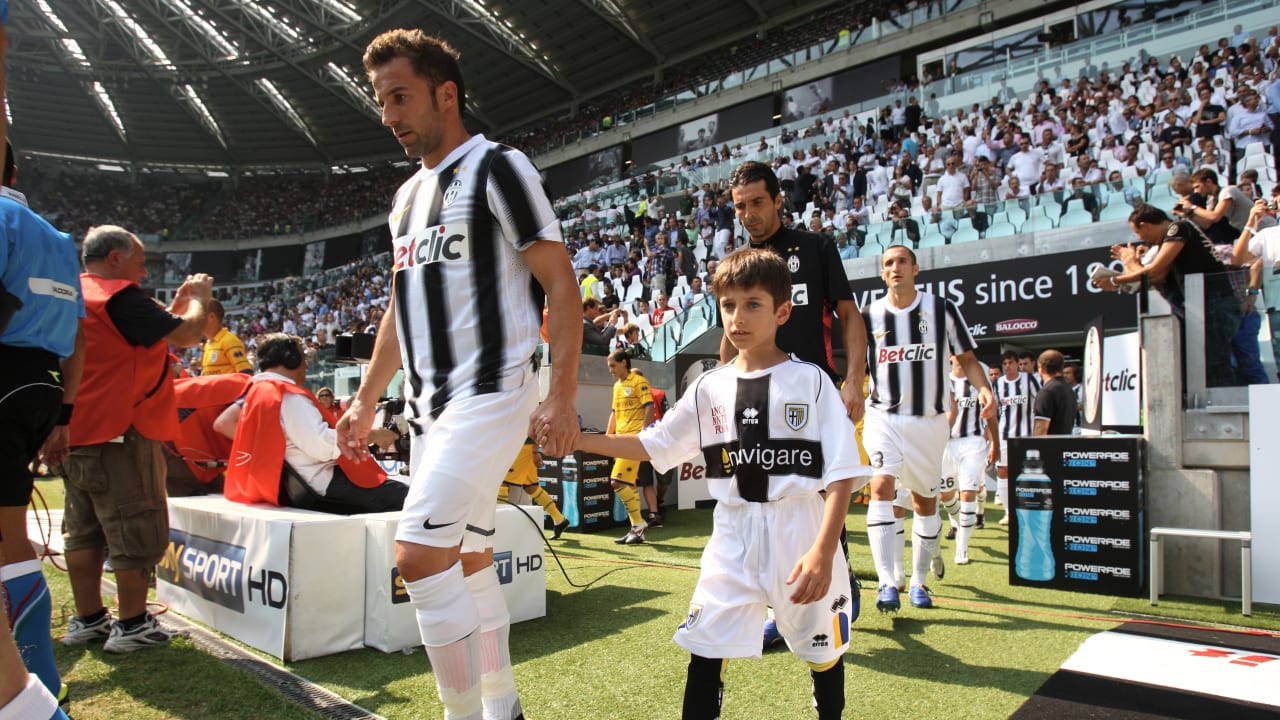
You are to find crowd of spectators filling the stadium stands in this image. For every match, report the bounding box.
[135,27,1280,368]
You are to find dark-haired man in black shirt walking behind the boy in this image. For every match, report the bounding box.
[721,160,867,421]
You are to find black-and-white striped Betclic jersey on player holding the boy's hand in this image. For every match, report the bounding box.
[389,135,563,418]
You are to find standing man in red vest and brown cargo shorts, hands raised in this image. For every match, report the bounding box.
[63,225,212,652]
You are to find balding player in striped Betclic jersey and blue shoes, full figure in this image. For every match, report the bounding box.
[863,245,996,612]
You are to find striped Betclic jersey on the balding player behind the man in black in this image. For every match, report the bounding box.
[863,291,977,418]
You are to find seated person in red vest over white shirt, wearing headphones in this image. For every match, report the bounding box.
[225,333,408,515]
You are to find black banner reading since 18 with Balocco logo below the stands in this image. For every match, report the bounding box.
[850,247,1138,340]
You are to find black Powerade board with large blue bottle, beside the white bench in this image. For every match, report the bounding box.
[1009,436,1147,597]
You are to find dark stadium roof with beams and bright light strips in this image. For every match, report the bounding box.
[6,0,837,169]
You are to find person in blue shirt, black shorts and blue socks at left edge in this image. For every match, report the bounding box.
[0,137,84,696]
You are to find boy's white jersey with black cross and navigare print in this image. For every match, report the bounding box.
[640,356,872,505]
